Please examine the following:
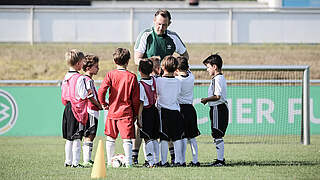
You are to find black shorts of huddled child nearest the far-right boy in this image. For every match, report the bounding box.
[180,104,200,139]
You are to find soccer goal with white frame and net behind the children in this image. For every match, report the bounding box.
[190,65,310,145]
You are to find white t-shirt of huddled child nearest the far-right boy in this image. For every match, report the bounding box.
[176,71,194,104]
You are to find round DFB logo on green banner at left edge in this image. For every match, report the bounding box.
[0,89,18,135]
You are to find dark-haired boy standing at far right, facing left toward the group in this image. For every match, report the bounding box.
[201,54,229,166]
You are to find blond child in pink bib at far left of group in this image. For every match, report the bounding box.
[61,49,90,168]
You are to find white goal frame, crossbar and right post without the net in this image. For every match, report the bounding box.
[190,65,310,145]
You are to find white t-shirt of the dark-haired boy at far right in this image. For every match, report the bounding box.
[208,74,227,106]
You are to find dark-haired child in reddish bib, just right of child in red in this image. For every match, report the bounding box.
[138,59,160,167]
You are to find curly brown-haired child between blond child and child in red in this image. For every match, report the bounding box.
[82,55,102,167]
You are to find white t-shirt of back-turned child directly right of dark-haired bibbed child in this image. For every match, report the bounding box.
[156,77,181,111]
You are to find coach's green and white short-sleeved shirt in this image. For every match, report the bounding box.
[134,28,187,59]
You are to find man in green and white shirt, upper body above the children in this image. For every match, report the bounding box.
[134,9,189,65]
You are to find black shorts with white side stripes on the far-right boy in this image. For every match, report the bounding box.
[210,104,229,138]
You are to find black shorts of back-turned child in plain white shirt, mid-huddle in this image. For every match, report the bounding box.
[160,108,184,141]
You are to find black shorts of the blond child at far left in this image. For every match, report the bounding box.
[62,102,83,141]
